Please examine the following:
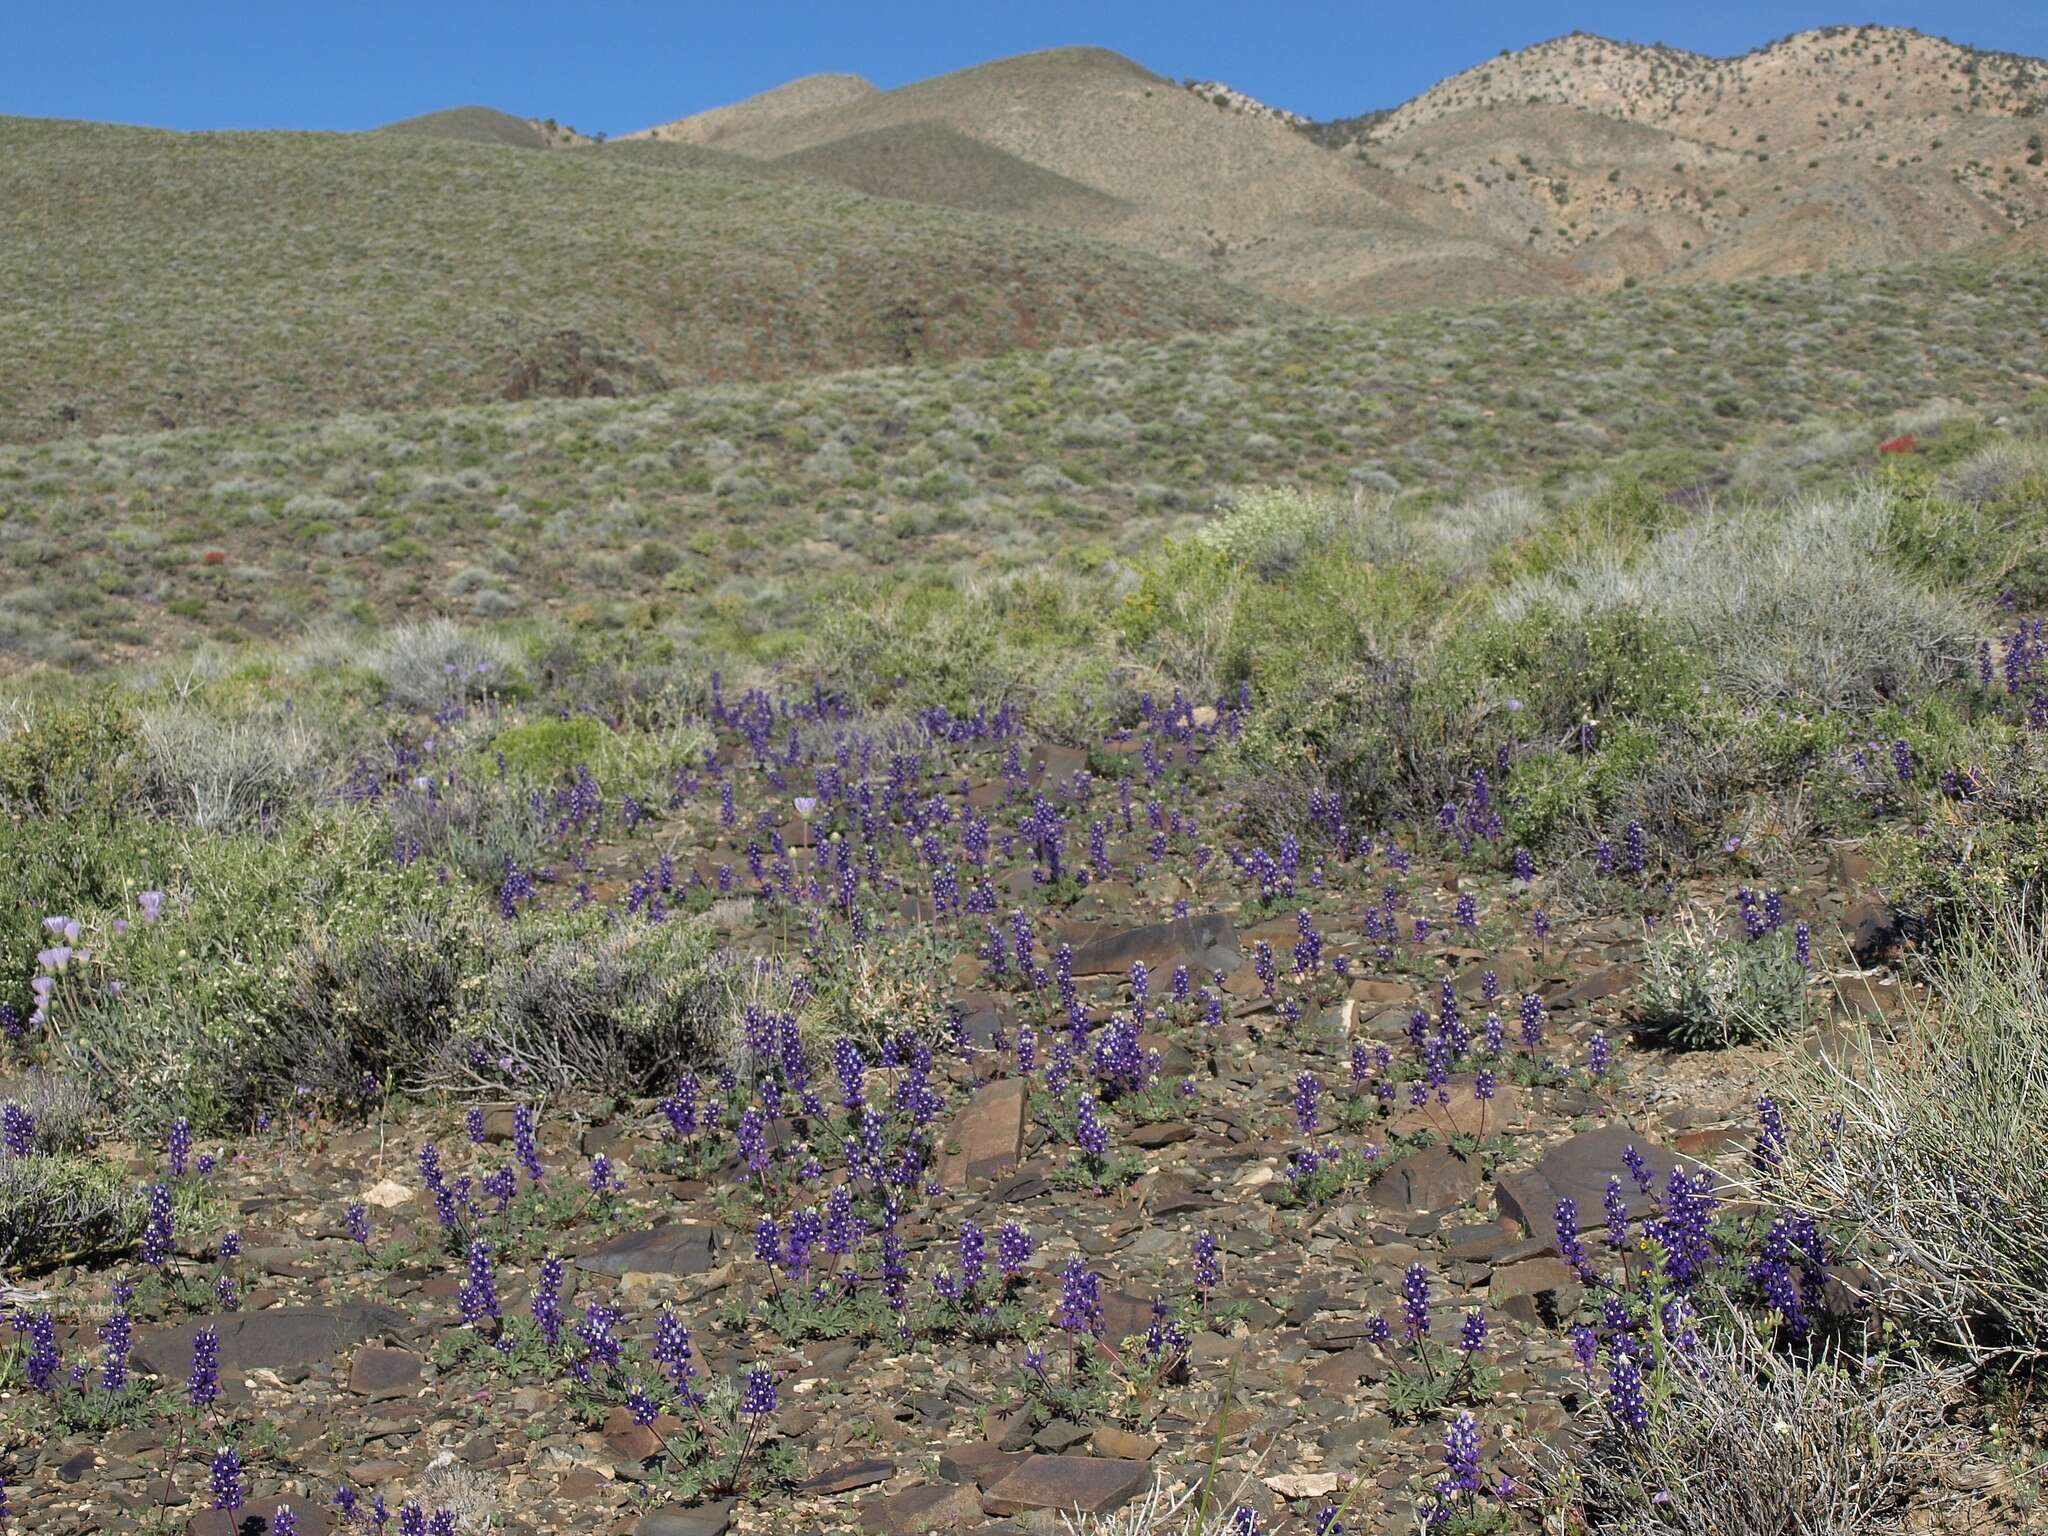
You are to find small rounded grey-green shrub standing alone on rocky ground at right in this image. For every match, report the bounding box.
[1634,911,1806,1051]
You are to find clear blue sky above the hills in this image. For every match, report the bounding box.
[0,0,2048,133]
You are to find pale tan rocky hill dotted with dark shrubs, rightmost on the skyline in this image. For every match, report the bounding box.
[1354,29,2048,285]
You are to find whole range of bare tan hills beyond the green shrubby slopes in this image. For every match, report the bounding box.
[610,27,2048,311]
